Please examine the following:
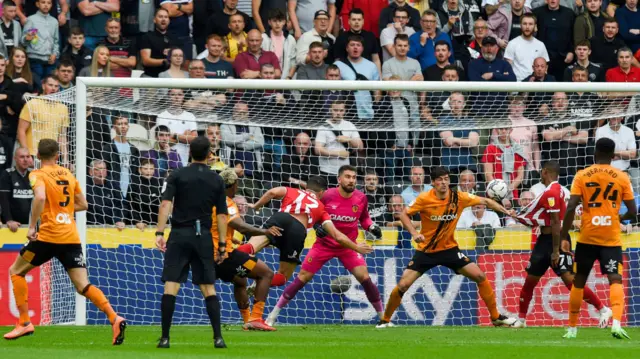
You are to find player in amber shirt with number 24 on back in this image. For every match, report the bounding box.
[551,137,638,339]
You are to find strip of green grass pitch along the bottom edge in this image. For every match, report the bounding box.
[0,325,640,359]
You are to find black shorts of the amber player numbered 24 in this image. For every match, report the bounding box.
[573,242,622,276]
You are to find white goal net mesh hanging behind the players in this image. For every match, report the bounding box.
[26,83,640,325]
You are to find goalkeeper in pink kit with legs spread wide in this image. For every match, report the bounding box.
[267,165,384,325]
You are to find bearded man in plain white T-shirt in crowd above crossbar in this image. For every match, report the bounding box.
[504,14,549,81]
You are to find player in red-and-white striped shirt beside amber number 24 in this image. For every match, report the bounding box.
[516,161,611,328]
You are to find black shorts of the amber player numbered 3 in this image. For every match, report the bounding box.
[20,241,87,270]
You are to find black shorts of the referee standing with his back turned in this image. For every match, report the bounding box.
[162,227,216,285]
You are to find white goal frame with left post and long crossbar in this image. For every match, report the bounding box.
[75,77,640,325]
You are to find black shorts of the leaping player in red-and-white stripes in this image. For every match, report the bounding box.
[262,212,307,264]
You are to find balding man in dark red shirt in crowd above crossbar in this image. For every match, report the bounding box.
[233,29,282,79]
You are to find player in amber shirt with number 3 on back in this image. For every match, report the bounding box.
[4,139,127,345]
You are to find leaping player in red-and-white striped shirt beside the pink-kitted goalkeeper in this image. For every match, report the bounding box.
[238,176,373,286]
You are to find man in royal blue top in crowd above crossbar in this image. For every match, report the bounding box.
[407,10,455,71]
